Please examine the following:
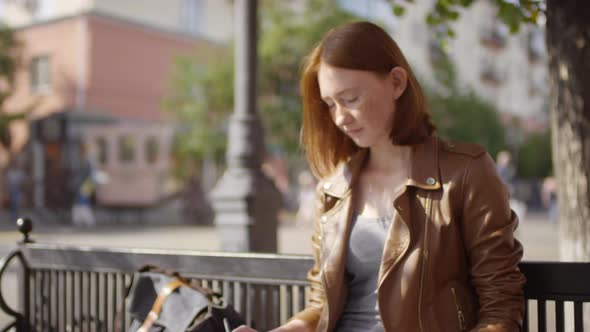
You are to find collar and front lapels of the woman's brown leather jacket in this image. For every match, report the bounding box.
[320,137,441,322]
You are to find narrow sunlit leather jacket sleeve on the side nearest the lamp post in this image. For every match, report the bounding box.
[290,182,326,331]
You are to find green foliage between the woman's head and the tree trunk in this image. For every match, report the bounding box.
[388,0,551,177]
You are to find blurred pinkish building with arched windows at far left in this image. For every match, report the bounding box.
[0,1,223,215]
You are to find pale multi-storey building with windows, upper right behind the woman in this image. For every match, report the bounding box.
[340,0,548,122]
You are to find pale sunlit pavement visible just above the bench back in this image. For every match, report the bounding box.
[0,213,559,260]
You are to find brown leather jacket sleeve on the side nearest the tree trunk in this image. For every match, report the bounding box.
[462,153,525,332]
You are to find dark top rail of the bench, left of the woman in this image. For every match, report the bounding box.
[23,244,313,283]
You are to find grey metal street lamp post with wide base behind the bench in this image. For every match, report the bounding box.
[212,0,281,252]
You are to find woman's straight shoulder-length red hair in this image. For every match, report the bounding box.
[300,22,435,178]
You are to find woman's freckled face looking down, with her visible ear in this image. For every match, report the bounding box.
[318,63,407,148]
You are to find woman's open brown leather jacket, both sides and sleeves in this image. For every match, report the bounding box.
[294,137,525,332]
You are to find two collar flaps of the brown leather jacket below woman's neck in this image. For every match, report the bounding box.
[322,136,440,198]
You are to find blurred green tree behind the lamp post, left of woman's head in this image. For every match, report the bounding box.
[164,0,364,176]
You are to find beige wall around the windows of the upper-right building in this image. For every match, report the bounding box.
[346,0,548,117]
